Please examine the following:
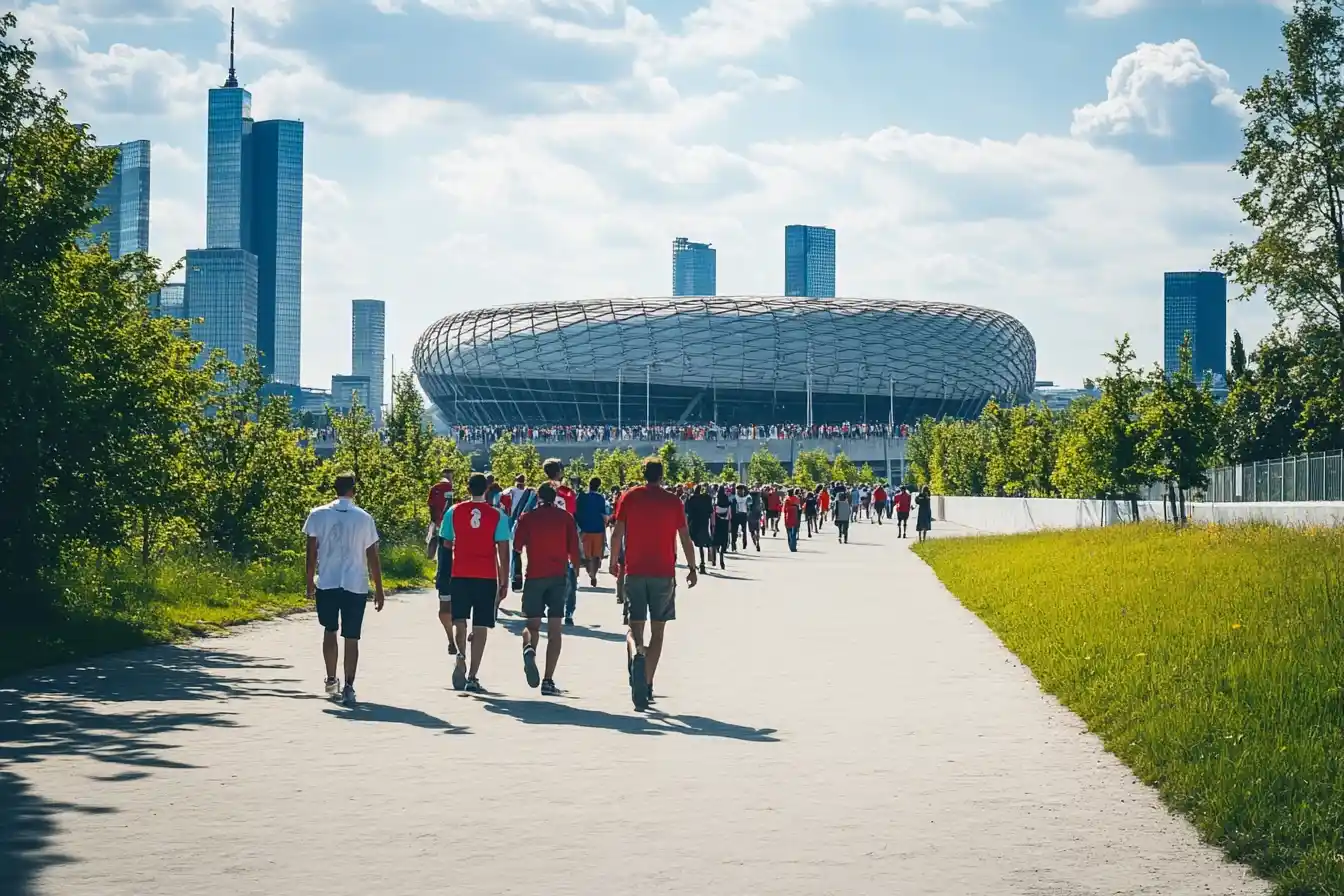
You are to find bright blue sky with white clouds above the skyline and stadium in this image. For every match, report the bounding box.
[7,0,1290,387]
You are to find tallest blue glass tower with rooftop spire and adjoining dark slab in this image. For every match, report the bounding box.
[188,11,304,384]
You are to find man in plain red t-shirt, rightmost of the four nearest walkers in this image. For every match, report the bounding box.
[612,457,696,709]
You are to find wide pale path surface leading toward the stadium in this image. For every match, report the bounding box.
[0,515,1265,896]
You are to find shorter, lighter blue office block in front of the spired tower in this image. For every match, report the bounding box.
[187,249,257,364]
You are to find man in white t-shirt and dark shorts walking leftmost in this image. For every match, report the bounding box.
[304,473,383,707]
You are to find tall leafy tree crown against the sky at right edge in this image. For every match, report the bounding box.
[1214,0,1344,343]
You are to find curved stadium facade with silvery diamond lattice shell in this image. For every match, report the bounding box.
[414,296,1036,426]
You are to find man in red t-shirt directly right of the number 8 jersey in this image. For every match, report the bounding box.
[513,482,579,697]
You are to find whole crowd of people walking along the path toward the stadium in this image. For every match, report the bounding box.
[304,457,933,709]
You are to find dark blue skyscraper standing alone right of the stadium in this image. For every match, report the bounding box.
[1163,271,1227,377]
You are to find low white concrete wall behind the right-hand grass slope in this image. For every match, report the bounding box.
[934,497,1344,535]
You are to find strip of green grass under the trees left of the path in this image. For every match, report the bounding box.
[0,547,434,677]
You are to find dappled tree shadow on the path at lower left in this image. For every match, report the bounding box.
[0,645,320,896]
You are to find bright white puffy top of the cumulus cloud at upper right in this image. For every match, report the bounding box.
[1073,38,1242,137]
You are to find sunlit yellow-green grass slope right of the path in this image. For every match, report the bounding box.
[917,524,1344,896]
